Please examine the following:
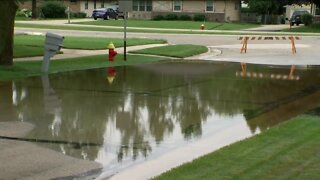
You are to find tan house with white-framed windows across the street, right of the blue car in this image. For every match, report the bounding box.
[129,0,241,21]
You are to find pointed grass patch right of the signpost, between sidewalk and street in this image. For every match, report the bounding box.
[130,44,208,58]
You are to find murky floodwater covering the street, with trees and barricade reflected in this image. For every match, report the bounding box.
[0,61,320,178]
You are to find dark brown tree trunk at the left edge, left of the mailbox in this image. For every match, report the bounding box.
[0,0,18,65]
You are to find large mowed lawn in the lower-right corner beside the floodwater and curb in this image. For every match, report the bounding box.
[155,115,320,180]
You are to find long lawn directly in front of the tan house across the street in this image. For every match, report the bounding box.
[76,19,260,30]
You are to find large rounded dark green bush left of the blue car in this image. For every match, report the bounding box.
[40,1,66,18]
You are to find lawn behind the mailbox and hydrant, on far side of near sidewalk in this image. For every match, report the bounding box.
[14,35,167,58]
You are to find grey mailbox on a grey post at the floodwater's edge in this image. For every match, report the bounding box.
[42,33,64,72]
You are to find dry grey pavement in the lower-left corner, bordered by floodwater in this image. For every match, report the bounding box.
[0,121,101,180]
